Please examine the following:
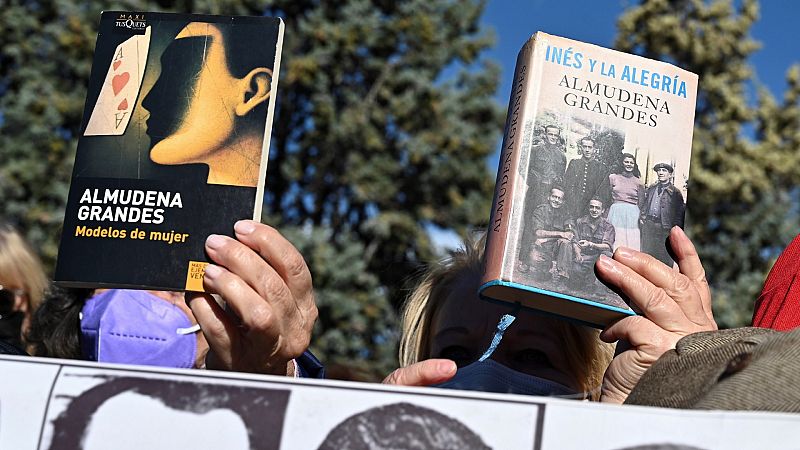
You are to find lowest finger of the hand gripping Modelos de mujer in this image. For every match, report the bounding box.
[185,292,238,365]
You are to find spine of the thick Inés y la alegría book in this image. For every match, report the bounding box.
[481,39,535,285]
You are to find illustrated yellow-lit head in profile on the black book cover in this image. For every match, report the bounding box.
[142,22,272,186]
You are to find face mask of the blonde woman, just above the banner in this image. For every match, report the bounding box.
[436,359,577,397]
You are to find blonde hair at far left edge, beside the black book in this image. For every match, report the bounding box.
[0,224,48,315]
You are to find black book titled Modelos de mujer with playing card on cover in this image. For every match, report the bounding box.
[55,11,283,291]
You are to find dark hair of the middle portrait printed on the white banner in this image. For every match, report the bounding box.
[318,403,490,450]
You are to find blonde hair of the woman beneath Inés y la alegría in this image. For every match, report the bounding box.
[399,235,613,399]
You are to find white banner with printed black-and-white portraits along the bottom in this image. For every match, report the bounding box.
[0,356,800,450]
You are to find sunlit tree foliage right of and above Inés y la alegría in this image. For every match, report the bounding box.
[616,0,800,327]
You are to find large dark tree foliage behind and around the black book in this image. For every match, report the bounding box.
[0,0,503,377]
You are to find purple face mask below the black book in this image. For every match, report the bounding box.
[81,289,199,368]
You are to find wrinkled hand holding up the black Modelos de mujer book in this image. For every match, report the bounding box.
[186,220,317,375]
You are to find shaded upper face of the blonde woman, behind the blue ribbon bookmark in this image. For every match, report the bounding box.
[429,273,580,390]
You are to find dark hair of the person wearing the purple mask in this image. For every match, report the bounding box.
[25,286,94,359]
